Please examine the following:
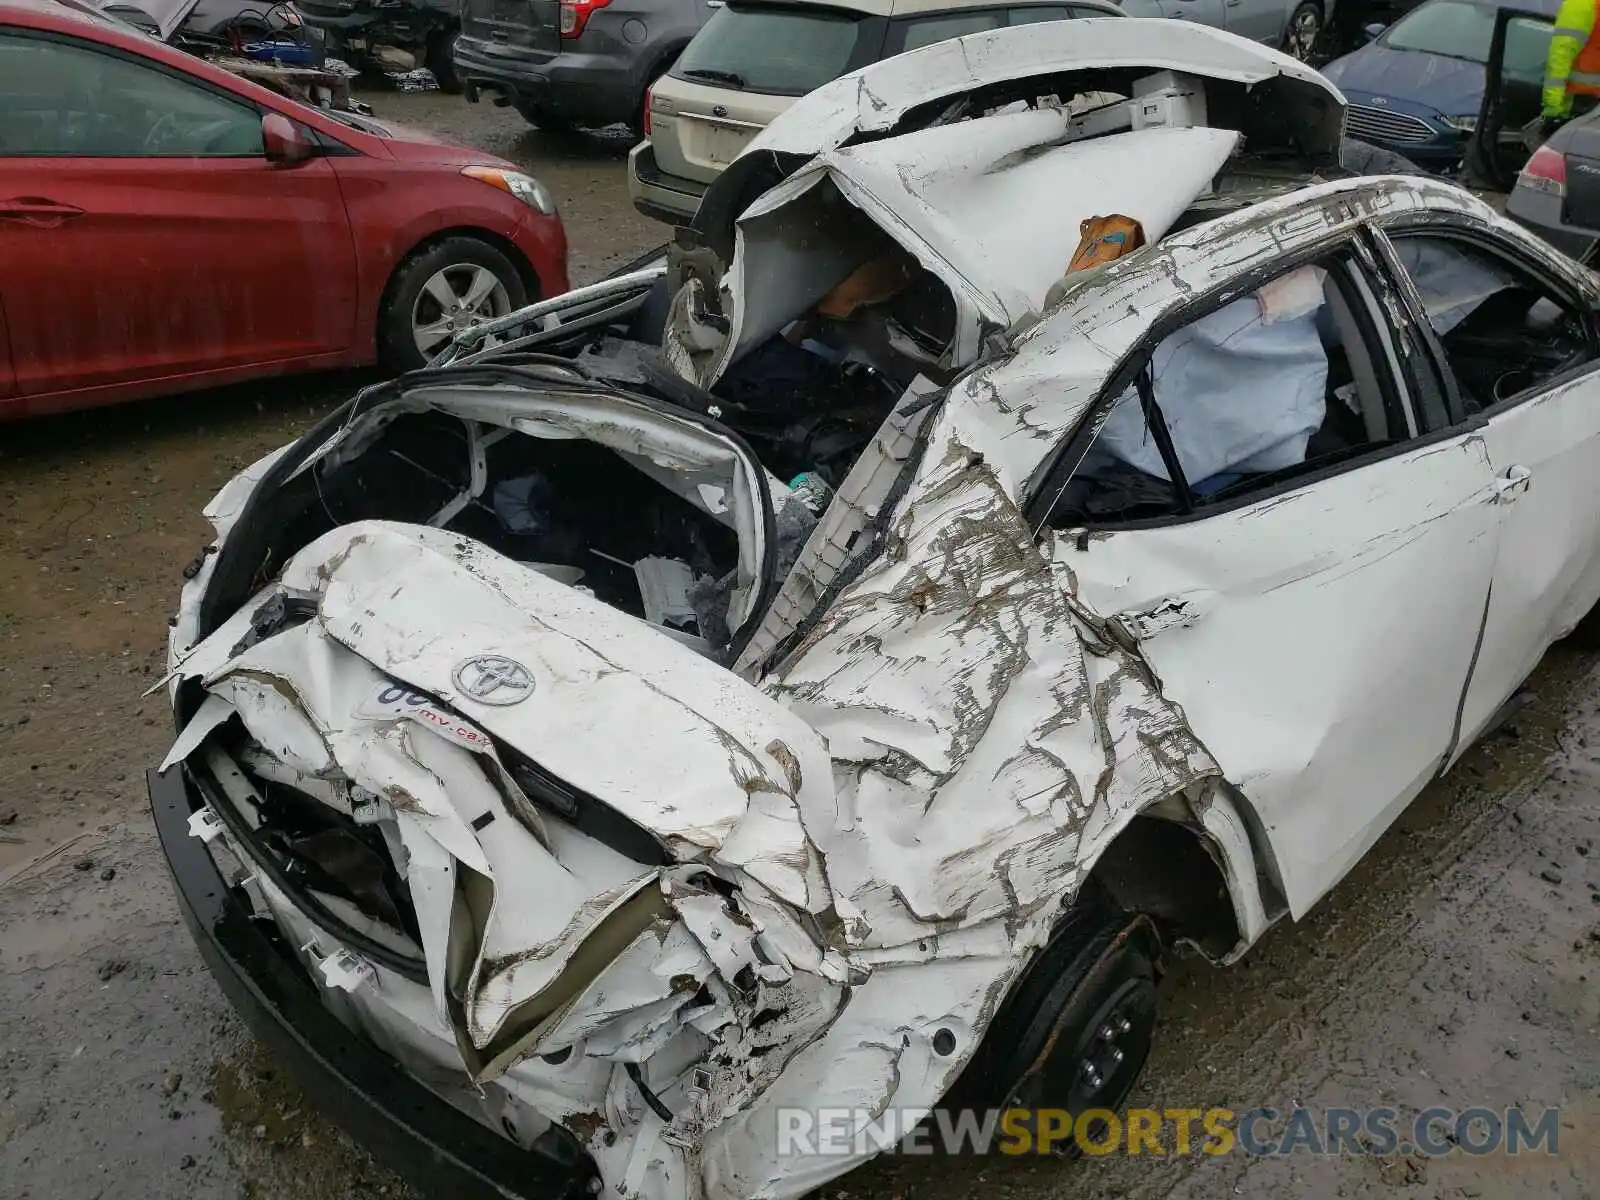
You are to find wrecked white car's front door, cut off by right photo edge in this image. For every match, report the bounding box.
[1390,222,1600,755]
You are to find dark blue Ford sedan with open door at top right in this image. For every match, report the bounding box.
[1322,0,1558,173]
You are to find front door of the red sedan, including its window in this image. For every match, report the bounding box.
[0,29,355,397]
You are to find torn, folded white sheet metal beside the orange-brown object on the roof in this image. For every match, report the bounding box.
[701,122,1240,384]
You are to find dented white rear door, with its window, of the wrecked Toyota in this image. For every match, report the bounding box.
[1046,235,1496,915]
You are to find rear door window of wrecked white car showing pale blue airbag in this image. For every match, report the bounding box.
[1050,251,1416,528]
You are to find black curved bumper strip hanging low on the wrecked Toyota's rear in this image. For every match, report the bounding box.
[146,766,594,1200]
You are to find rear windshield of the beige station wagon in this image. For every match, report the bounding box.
[672,5,882,96]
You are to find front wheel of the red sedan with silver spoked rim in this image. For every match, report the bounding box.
[378,237,528,374]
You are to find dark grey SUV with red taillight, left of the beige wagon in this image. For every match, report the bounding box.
[456,0,718,133]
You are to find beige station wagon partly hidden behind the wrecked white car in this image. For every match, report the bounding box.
[627,0,1120,224]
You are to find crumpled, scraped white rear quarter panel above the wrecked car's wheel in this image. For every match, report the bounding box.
[770,410,1214,947]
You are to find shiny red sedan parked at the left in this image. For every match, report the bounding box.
[0,0,566,419]
